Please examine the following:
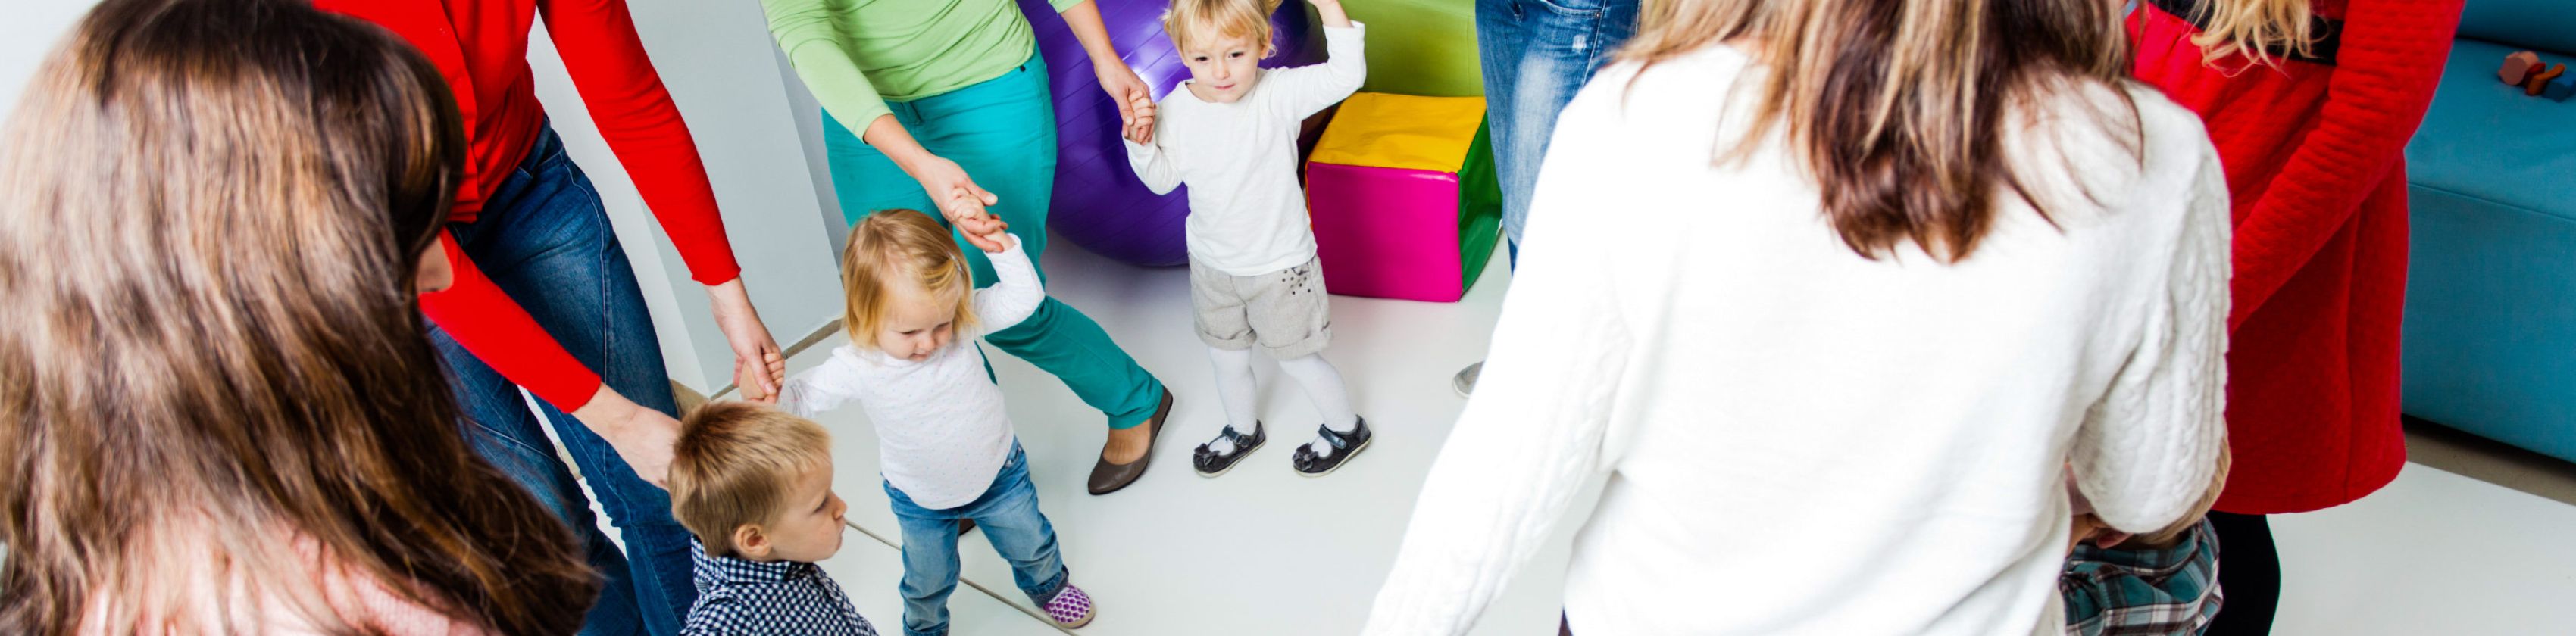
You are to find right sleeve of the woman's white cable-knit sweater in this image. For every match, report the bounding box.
[2068,142,2228,533]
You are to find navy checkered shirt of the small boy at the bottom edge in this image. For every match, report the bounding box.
[680,541,876,636]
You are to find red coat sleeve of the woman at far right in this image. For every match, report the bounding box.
[2228,0,2460,329]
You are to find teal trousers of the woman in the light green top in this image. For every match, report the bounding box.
[822,54,1161,428]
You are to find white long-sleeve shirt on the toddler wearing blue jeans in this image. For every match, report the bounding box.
[778,237,1046,510]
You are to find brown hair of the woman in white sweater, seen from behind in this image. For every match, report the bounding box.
[1623,0,2146,263]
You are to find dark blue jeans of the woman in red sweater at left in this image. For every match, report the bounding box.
[430,129,698,634]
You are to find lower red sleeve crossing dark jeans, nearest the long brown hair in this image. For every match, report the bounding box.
[420,229,600,412]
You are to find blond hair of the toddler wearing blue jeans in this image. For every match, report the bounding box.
[839,208,974,348]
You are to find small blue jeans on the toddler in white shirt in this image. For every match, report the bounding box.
[886,441,1069,636]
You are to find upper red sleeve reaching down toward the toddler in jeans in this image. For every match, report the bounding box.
[539,0,742,285]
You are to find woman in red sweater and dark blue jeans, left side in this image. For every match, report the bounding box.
[314,0,783,634]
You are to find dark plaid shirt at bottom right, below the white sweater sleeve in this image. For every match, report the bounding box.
[2059,520,2223,636]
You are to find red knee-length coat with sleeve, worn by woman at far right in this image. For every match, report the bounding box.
[2131,0,2460,515]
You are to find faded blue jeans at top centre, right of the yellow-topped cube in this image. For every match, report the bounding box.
[1476,0,1638,263]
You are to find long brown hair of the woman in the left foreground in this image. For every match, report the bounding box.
[0,0,598,634]
